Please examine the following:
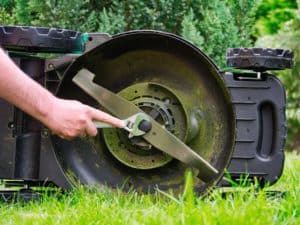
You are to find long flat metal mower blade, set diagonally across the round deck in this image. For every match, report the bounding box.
[73,69,219,182]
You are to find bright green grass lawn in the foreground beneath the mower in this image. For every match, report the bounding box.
[0,154,300,225]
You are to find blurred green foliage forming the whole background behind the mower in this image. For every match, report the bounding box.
[0,0,300,148]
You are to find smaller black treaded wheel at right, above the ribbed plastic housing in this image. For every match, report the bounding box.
[226,48,294,72]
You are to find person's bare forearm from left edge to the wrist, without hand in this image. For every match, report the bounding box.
[0,49,55,124]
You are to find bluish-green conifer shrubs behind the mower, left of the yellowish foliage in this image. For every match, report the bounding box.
[0,0,257,67]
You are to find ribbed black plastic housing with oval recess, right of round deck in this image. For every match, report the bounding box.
[220,73,287,186]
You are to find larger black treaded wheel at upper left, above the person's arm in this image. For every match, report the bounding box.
[0,26,84,53]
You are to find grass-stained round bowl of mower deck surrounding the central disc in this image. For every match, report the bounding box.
[52,31,235,191]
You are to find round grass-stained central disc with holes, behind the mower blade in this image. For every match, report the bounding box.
[103,83,187,169]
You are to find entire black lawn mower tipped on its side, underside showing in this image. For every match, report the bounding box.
[0,27,292,195]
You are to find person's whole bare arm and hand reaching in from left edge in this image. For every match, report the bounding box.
[0,49,124,138]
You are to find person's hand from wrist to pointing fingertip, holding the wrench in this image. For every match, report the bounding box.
[42,98,124,139]
